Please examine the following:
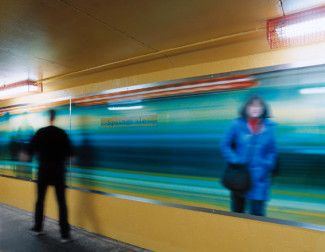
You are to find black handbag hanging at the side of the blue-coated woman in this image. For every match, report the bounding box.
[222,163,252,192]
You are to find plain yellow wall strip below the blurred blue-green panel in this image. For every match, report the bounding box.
[0,177,325,252]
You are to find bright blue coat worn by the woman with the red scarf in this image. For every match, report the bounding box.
[221,118,276,200]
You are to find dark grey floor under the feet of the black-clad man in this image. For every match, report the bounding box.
[0,204,148,252]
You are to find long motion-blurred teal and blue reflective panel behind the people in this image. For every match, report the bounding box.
[0,66,325,225]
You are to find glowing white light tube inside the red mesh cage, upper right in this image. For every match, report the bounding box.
[275,17,325,38]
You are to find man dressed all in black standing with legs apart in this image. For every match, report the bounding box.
[28,110,72,242]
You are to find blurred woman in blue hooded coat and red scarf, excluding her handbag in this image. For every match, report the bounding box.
[221,96,276,216]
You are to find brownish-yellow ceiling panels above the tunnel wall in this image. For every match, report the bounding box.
[0,0,321,84]
